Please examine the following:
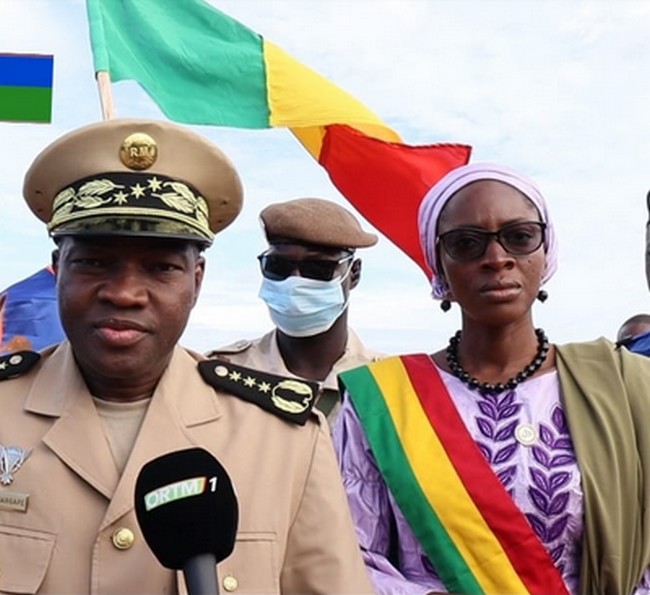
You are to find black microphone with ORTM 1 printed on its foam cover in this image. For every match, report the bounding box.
[135,448,239,595]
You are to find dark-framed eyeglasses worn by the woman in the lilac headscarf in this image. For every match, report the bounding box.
[437,221,546,262]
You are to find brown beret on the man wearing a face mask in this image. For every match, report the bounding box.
[260,198,377,248]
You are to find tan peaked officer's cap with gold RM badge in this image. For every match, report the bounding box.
[23,119,243,245]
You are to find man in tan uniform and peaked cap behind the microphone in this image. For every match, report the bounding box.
[0,120,371,595]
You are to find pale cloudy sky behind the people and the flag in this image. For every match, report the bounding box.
[0,0,650,353]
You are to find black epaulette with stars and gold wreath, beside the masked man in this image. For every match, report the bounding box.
[199,359,320,426]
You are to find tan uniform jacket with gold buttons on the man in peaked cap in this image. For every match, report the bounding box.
[0,343,372,595]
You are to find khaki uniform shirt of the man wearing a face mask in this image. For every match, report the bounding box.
[207,329,385,426]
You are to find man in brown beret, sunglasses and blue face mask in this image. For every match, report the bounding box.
[208,198,382,426]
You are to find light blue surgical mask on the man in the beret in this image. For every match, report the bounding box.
[260,267,352,337]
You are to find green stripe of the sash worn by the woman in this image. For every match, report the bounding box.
[339,366,483,595]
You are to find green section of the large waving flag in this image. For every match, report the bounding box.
[88,0,270,128]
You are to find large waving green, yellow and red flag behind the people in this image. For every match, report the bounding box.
[87,0,471,274]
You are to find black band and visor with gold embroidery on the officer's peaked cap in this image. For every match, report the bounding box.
[47,172,214,244]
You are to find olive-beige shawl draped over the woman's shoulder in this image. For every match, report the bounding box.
[557,339,650,595]
